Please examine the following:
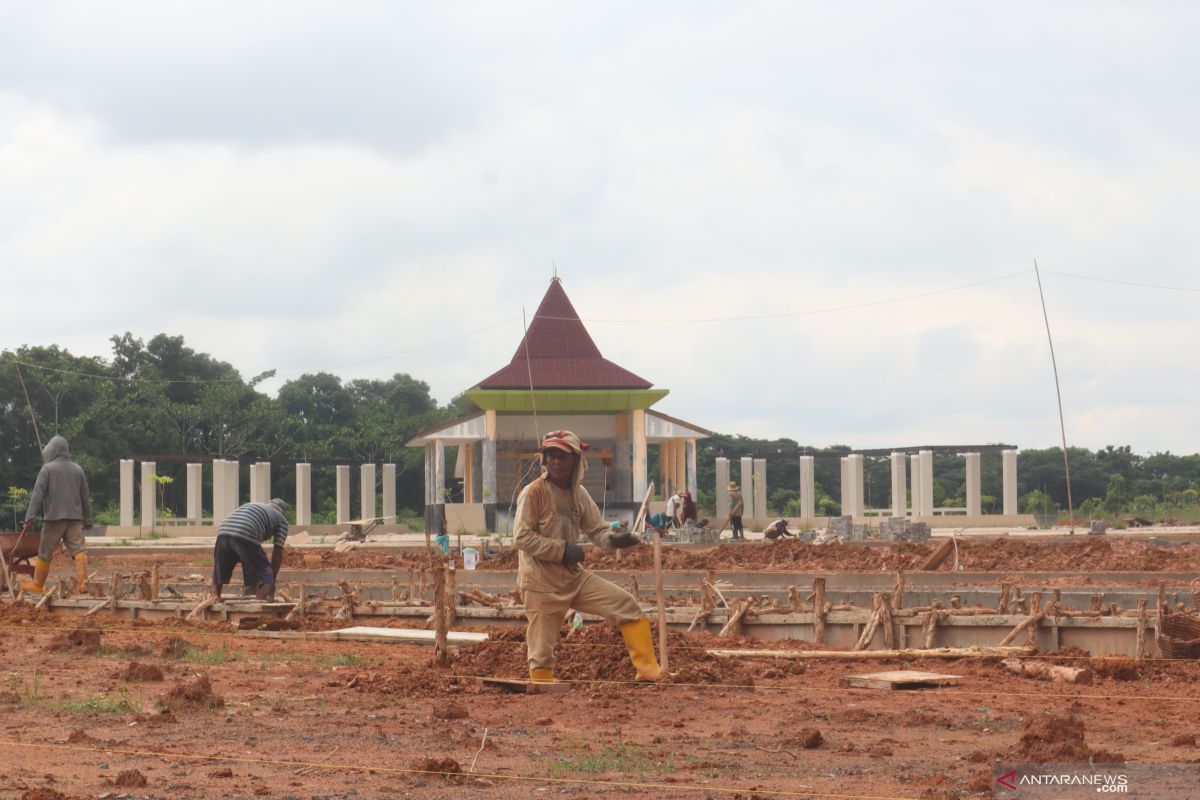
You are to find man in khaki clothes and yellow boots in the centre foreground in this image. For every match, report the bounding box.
[515,431,661,681]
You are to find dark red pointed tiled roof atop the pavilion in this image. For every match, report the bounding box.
[479,278,653,389]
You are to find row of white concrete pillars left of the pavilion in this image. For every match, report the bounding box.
[120,458,396,530]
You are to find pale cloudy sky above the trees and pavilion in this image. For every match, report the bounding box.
[0,0,1200,452]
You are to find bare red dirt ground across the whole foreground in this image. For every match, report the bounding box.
[0,597,1200,800]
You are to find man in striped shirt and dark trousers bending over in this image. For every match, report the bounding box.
[212,498,288,600]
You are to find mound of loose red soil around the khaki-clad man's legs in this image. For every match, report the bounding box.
[454,622,754,686]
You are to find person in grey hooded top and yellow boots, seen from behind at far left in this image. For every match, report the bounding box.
[20,437,92,591]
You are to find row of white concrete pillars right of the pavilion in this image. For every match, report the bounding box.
[716,450,1018,519]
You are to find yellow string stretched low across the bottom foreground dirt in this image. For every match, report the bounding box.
[0,739,917,800]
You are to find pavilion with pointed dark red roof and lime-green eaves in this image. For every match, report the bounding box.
[408,277,710,533]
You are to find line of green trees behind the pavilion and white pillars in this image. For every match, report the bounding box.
[0,333,1200,527]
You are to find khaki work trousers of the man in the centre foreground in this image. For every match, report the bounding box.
[522,571,646,669]
